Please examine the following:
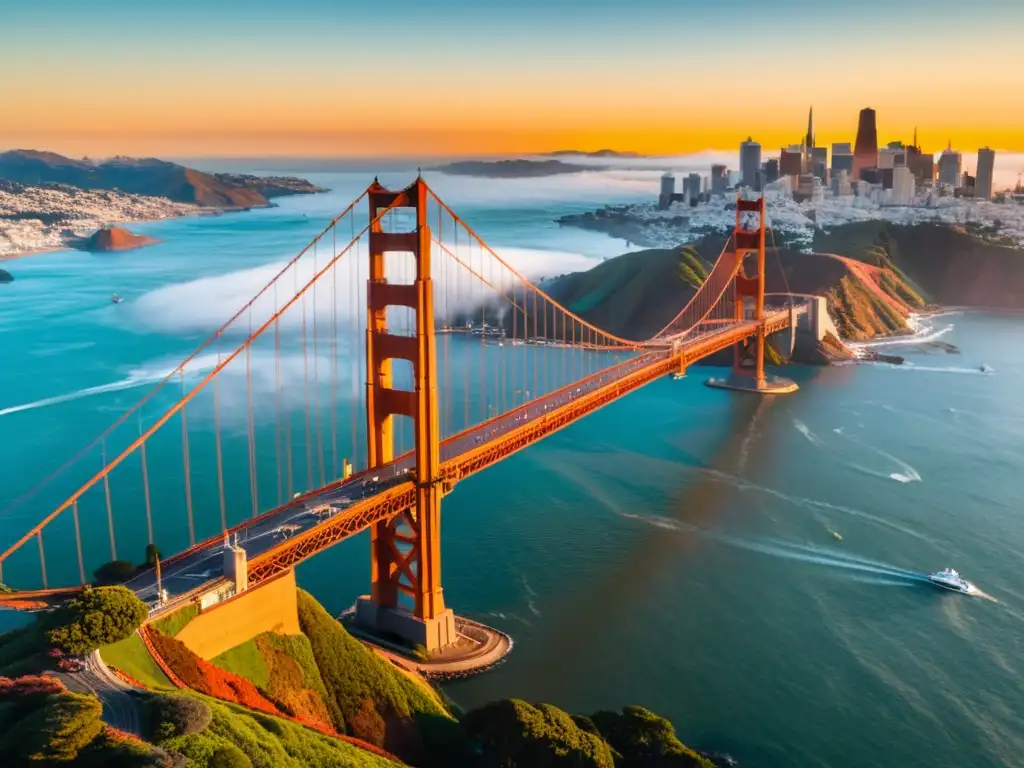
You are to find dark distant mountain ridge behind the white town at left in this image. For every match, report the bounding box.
[0,150,323,209]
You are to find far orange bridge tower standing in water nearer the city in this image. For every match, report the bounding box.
[708,196,798,394]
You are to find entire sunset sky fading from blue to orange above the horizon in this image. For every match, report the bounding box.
[0,0,1024,157]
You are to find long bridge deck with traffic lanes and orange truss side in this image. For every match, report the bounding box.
[119,312,790,605]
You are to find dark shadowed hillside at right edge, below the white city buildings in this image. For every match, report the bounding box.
[814,221,1024,309]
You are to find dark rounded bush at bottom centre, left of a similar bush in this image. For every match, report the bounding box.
[463,698,614,768]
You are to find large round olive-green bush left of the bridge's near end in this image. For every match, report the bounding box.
[46,587,150,654]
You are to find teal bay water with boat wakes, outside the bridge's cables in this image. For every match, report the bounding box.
[0,167,1024,768]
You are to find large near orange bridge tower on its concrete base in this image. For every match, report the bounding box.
[355,178,457,651]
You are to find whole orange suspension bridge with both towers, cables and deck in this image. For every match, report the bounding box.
[0,178,804,649]
